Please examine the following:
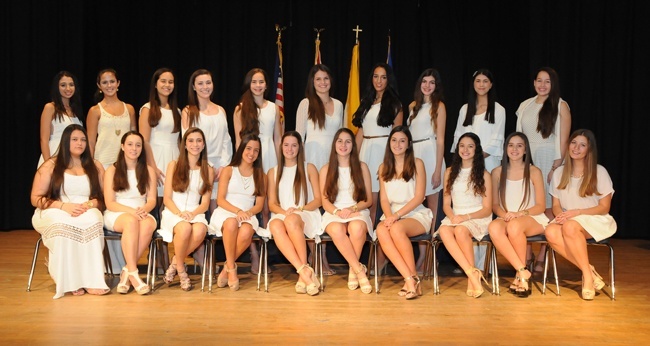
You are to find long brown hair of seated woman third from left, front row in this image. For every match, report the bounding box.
[172,127,212,195]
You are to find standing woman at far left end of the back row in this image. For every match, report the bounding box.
[38,71,82,167]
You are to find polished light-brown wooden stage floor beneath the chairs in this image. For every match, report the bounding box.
[0,230,650,345]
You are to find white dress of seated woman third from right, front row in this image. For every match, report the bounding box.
[441,168,492,240]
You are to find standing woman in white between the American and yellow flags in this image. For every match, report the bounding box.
[296,64,343,275]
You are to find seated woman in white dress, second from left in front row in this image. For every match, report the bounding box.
[104,131,156,295]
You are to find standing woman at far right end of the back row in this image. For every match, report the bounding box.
[516,67,571,271]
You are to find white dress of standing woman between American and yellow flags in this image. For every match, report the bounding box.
[296,98,343,171]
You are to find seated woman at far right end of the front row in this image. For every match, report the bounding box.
[546,129,616,300]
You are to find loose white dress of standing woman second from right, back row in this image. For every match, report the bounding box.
[451,102,506,172]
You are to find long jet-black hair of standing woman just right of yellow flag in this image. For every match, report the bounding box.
[352,63,402,128]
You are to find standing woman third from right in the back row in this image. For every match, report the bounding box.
[408,68,447,273]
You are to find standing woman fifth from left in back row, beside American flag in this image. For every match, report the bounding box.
[233,68,282,274]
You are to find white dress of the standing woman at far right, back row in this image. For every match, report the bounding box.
[516,96,569,209]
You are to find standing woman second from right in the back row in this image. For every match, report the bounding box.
[451,69,506,268]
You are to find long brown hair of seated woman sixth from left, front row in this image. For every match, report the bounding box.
[325,127,368,203]
